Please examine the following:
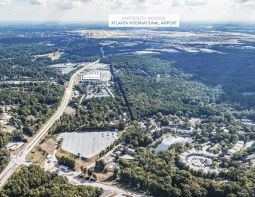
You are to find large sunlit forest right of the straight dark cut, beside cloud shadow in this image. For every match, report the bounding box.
[103,56,227,119]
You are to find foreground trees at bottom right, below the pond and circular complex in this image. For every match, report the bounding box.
[119,145,255,197]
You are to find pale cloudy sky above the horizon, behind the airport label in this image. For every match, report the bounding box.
[0,0,255,23]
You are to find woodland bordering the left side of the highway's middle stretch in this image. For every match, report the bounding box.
[0,83,64,136]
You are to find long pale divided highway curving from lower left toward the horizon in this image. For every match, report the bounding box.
[0,60,99,188]
